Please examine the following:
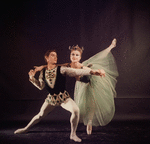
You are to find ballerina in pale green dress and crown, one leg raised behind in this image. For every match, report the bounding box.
[36,39,119,135]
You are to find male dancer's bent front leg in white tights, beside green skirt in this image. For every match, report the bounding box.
[61,98,81,142]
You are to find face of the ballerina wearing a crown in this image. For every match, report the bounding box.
[70,50,81,62]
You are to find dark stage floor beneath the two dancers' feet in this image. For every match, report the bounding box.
[0,120,150,144]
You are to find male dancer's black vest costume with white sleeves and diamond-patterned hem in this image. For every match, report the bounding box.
[30,66,90,106]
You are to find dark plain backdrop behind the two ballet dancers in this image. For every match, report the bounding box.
[0,0,150,120]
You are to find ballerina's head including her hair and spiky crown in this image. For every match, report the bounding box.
[69,45,84,63]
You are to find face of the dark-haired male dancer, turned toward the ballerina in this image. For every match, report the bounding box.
[46,52,57,64]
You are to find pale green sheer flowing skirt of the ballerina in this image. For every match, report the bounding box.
[74,48,118,126]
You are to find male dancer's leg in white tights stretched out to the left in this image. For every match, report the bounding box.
[14,102,55,134]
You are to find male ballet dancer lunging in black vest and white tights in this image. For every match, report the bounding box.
[14,50,101,142]
